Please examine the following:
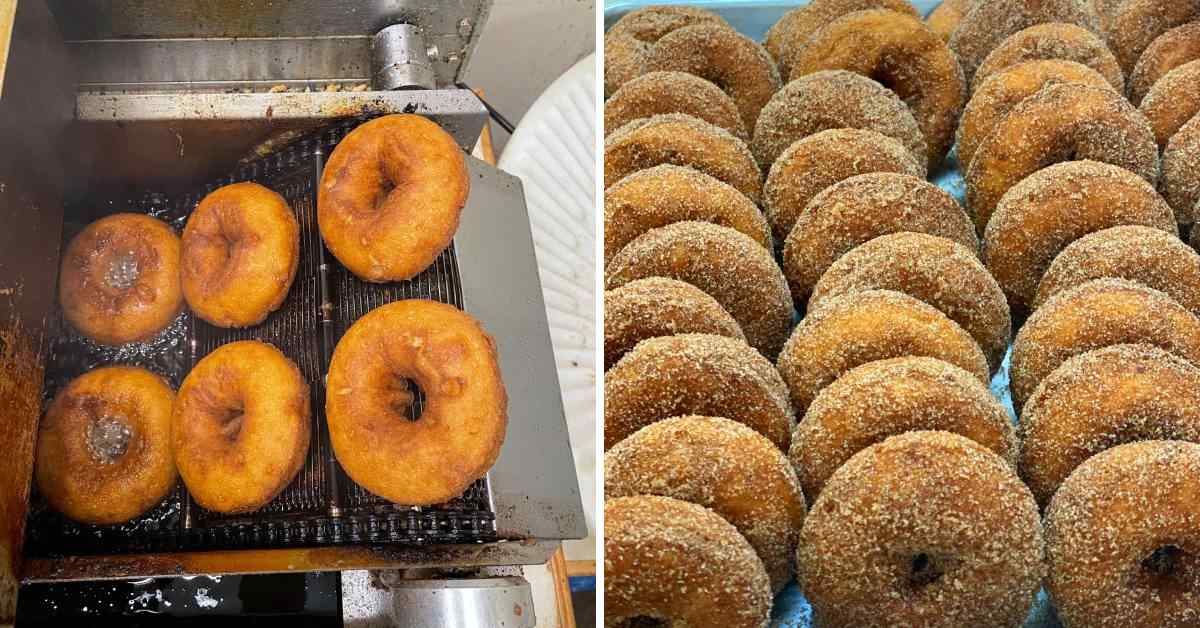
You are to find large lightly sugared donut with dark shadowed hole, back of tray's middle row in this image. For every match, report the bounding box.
[790,10,967,171]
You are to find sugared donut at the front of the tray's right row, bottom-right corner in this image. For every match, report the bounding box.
[1045,441,1200,628]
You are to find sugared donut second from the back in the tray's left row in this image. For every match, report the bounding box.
[646,24,780,128]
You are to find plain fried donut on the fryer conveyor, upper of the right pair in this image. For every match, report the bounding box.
[317,114,470,282]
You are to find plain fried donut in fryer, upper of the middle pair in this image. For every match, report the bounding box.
[180,181,300,327]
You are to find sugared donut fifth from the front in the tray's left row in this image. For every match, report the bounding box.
[605,222,792,357]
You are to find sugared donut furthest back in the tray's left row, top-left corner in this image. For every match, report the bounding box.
[604,5,730,98]
